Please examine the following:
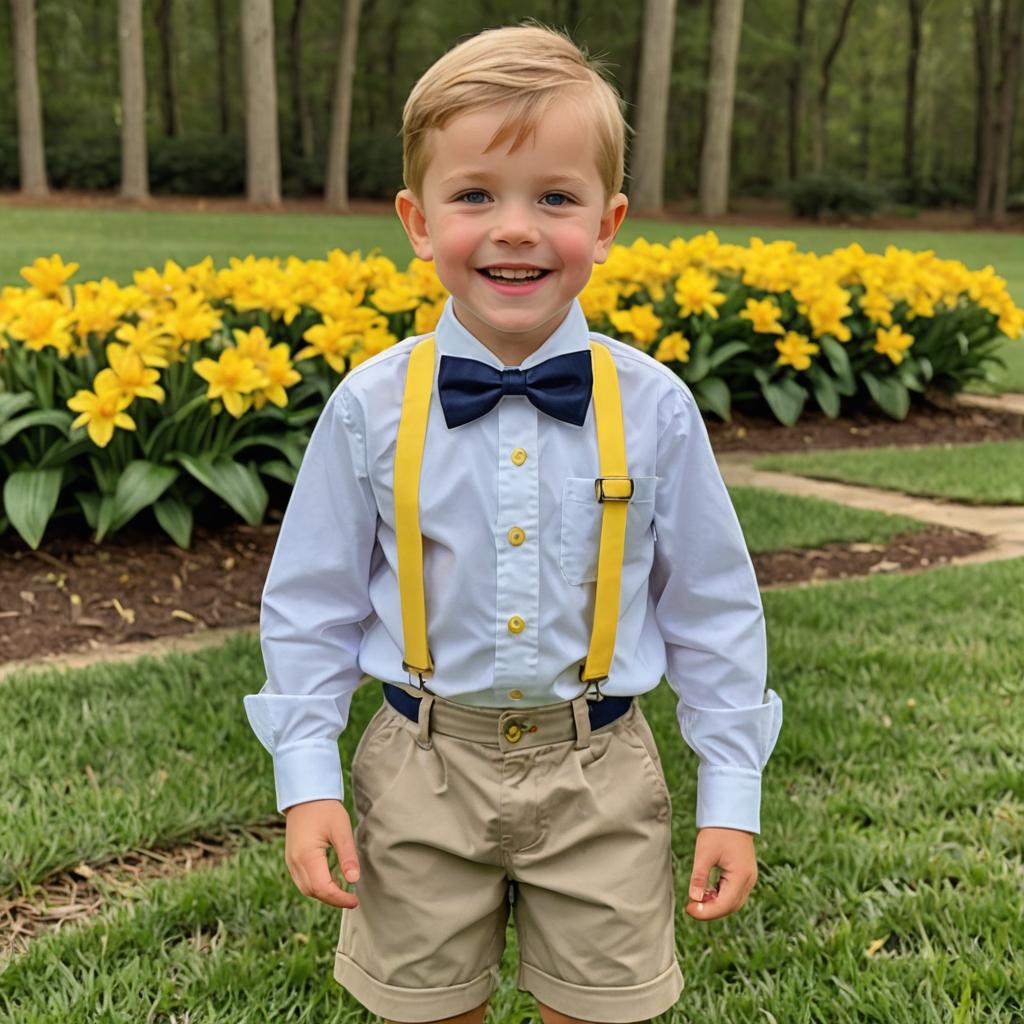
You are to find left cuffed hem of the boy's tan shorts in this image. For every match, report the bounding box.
[334,952,497,1022]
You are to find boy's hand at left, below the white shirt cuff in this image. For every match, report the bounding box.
[285,800,359,909]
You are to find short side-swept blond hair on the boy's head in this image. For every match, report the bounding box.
[401,19,633,202]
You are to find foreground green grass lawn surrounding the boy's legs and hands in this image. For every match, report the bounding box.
[0,559,1024,1024]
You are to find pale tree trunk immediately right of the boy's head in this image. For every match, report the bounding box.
[631,0,676,214]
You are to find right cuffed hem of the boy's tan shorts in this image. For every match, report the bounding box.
[516,959,685,1024]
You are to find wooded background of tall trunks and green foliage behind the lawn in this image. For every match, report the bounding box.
[0,0,1024,223]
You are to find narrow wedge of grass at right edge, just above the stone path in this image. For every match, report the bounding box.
[754,440,1024,505]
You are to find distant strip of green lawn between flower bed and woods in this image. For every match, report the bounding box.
[0,207,1024,391]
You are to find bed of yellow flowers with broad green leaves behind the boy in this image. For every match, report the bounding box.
[0,232,1024,548]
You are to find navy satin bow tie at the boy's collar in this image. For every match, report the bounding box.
[437,351,594,429]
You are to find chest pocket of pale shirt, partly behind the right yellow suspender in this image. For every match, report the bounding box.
[558,476,657,586]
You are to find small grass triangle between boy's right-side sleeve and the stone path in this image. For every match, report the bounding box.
[729,487,927,554]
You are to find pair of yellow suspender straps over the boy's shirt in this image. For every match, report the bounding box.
[394,335,633,692]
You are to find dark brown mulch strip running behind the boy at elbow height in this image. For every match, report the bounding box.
[0,497,987,663]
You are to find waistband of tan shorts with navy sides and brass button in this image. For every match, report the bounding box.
[384,683,634,751]
